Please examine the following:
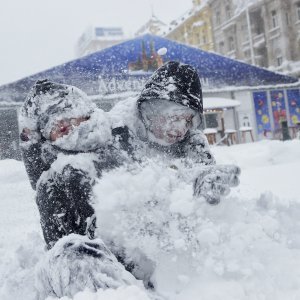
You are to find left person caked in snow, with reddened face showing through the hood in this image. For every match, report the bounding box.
[19,80,140,299]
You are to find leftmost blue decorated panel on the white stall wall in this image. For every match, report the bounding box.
[253,91,272,138]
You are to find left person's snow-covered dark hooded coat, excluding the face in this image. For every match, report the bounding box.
[19,80,124,248]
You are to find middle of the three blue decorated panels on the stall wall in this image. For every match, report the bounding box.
[270,91,286,131]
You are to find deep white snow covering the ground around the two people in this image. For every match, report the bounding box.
[0,140,300,300]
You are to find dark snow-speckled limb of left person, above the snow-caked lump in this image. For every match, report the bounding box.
[36,165,96,249]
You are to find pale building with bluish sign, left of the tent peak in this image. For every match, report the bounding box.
[76,27,125,57]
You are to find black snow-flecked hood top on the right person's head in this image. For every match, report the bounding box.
[137,61,203,114]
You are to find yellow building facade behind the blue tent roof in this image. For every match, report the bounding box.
[163,0,214,51]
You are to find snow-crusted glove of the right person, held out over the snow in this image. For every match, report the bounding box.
[194,165,241,205]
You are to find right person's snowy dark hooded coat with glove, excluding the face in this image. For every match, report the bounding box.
[110,61,240,204]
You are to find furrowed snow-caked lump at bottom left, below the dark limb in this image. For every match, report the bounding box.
[35,234,141,299]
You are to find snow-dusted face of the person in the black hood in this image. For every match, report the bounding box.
[149,112,194,144]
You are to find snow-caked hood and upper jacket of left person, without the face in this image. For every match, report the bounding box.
[19,80,124,189]
